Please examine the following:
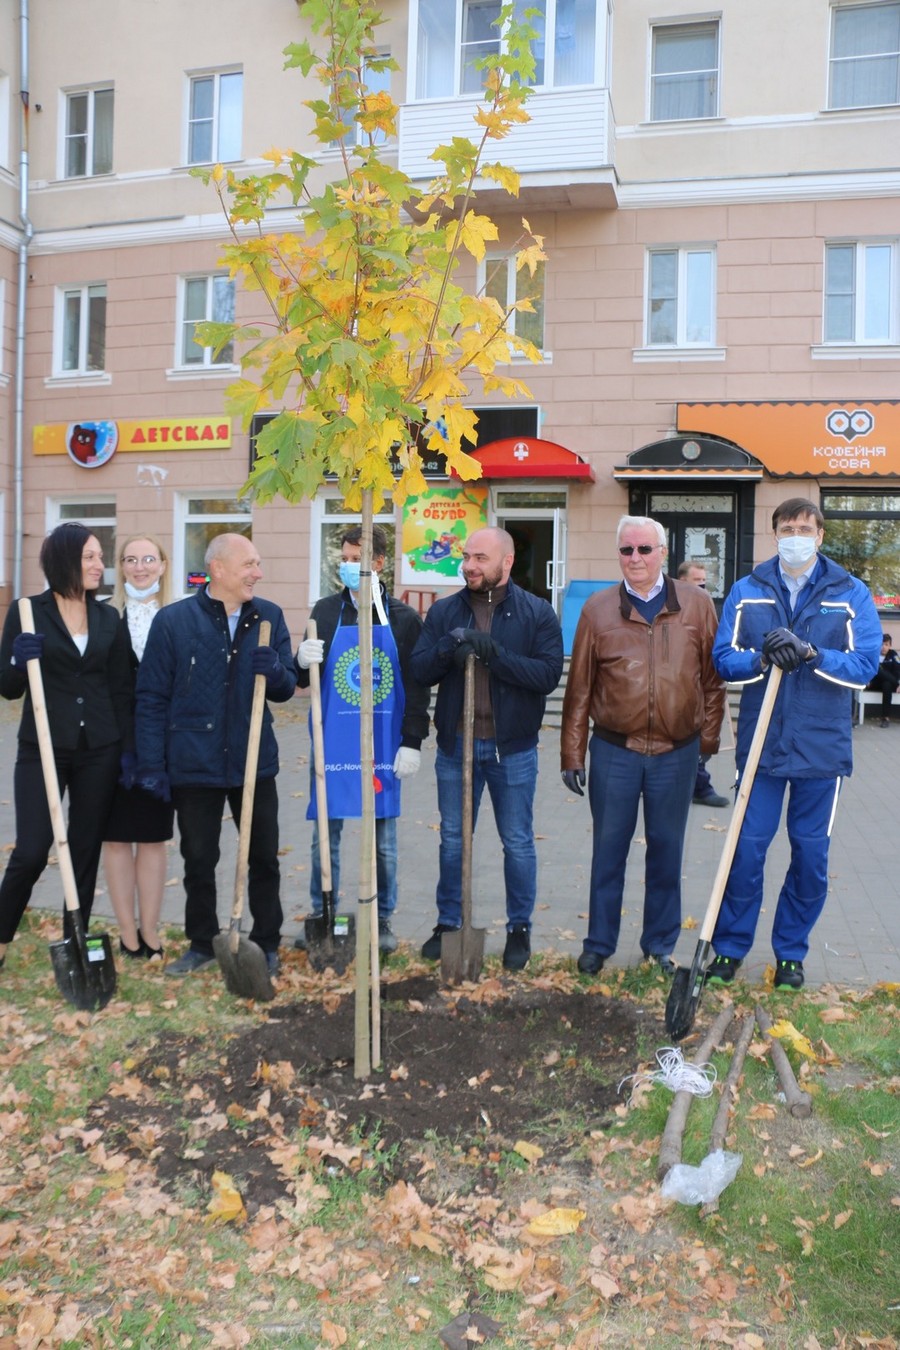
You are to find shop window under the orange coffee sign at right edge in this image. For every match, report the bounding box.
[820,490,900,614]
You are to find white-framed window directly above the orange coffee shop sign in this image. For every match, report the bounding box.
[823,239,900,344]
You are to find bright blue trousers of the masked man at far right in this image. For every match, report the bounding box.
[712,774,842,961]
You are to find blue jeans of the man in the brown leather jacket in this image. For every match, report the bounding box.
[584,736,698,957]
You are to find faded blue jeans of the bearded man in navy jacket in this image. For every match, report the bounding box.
[434,736,537,927]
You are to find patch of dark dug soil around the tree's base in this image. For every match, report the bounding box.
[93,979,663,1204]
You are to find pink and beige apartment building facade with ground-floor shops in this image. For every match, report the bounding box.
[0,0,900,633]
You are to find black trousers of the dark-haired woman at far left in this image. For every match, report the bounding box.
[0,741,120,942]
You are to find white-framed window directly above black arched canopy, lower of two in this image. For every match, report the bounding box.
[645,246,715,347]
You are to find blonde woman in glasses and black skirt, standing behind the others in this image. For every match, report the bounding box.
[103,535,175,961]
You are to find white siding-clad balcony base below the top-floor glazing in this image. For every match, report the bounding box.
[398,85,618,212]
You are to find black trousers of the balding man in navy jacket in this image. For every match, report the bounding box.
[171,778,283,956]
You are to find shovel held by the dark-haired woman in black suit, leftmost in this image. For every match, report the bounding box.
[19,595,116,1013]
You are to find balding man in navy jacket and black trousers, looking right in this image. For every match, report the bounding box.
[135,533,297,975]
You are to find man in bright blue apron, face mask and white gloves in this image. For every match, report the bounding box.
[294,525,430,953]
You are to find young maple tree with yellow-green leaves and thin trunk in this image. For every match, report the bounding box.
[197,0,545,1072]
